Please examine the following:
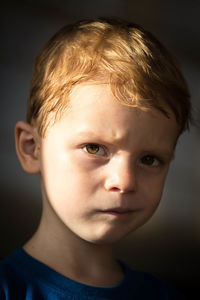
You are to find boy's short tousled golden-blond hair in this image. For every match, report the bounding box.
[27,19,191,136]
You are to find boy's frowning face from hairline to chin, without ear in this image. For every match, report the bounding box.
[37,84,178,244]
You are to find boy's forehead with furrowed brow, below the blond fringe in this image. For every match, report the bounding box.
[49,84,178,151]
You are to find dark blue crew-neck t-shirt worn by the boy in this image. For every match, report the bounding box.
[0,247,182,300]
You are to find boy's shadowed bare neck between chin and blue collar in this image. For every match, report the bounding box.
[24,209,123,286]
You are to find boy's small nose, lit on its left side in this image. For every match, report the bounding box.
[105,157,137,194]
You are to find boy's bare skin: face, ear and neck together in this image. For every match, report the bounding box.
[16,84,179,286]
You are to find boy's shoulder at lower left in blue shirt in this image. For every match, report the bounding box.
[0,247,78,300]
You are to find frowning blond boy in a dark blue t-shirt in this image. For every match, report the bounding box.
[0,19,190,300]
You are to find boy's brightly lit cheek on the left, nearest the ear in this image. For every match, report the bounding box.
[41,149,98,203]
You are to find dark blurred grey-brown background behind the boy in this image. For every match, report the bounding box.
[0,0,200,299]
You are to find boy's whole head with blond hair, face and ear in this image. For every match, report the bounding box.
[16,17,190,243]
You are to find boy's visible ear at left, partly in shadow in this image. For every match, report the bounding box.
[15,121,40,174]
